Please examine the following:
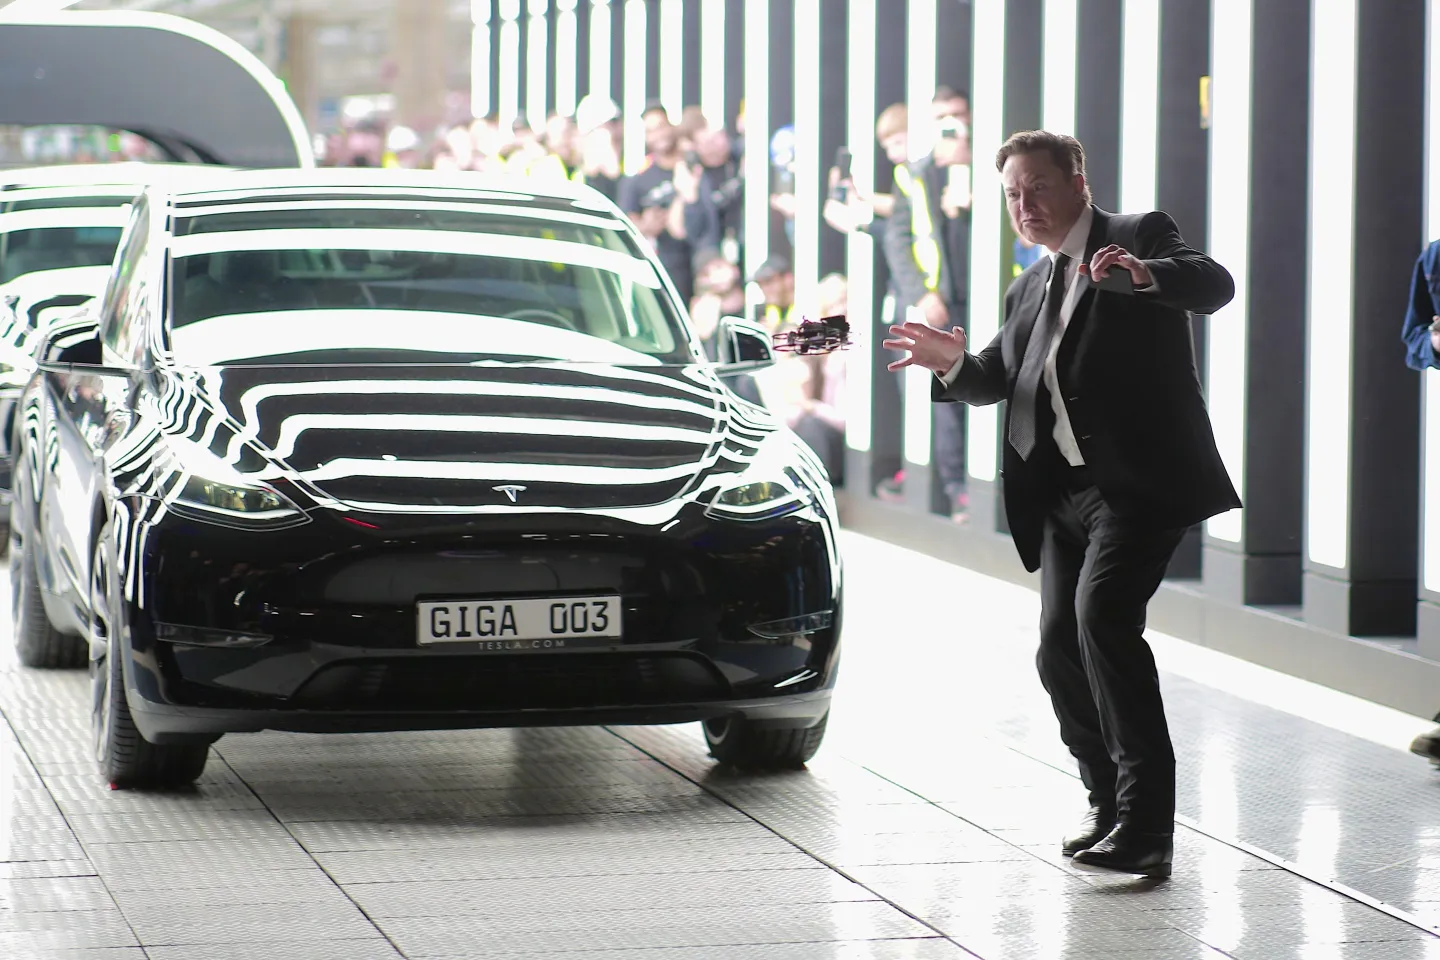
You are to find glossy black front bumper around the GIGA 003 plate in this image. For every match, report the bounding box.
[127,503,840,741]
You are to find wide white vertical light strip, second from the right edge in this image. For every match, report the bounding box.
[1305,0,1358,569]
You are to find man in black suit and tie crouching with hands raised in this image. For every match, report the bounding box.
[884,131,1240,877]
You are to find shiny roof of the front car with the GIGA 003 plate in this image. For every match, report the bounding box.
[157,167,618,214]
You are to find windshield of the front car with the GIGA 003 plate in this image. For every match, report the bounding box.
[167,199,694,366]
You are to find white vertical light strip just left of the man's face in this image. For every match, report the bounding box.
[965,3,1008,481]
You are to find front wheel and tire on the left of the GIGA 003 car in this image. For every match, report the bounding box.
[89,524,210,790]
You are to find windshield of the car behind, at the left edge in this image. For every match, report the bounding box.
[0,197,130,284]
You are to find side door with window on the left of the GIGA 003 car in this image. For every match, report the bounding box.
[37,203,151,622]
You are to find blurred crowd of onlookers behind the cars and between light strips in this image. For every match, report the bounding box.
[321,86,984,509]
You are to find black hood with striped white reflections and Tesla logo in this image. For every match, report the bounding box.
[186,363,730,512]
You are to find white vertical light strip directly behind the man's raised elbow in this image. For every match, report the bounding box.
[1205,0,1254,543]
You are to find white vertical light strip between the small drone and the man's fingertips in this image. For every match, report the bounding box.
[845,0,881,450]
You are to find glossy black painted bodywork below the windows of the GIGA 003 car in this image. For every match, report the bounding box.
[12,172,841,743]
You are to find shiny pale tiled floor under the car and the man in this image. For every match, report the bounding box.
[0,535,1440,960]
